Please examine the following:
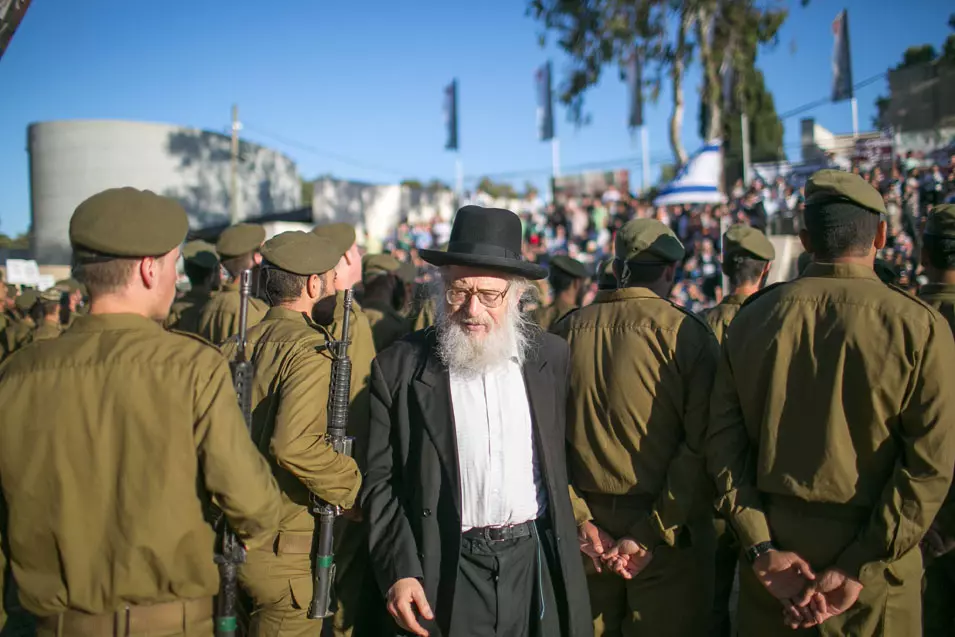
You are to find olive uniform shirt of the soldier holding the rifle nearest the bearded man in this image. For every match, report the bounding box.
[222,307,361,531]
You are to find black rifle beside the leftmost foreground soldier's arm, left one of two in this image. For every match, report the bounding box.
[215,270,252,637]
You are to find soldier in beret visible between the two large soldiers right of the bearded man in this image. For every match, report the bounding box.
[700,224,776,343]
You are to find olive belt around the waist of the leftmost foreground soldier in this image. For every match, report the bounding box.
[39,597,213,637]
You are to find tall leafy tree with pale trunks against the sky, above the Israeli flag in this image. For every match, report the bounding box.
[529,0,792,165]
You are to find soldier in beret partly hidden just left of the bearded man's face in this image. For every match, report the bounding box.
[362,254,411,352]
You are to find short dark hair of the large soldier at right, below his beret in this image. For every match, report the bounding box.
[805,202,882,260]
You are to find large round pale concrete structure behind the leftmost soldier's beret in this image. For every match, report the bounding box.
[27,120,301,263]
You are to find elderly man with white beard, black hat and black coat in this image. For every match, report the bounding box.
[361,206,593,637]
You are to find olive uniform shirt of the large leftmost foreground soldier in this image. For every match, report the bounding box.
[0,314,280,617]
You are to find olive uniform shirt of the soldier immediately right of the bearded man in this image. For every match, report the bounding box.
[555,287,718,548]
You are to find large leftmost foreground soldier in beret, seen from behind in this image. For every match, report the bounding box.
[0,188,280,637]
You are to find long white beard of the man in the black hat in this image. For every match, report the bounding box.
[434,287,536,377]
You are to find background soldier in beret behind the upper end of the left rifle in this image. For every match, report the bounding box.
[198,223,268,345]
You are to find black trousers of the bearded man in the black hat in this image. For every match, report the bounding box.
[450,526,567,637]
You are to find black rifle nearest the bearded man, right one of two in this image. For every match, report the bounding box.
[308,290,354,619]
